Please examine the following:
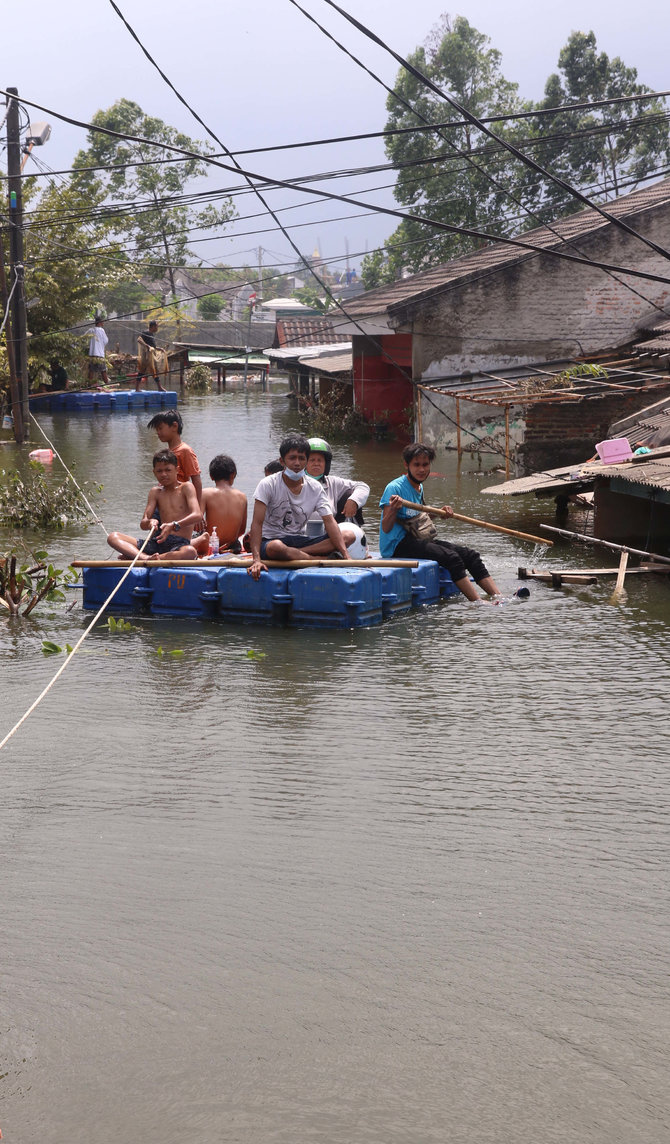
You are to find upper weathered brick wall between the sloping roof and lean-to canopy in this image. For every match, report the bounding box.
[400,204,670,382]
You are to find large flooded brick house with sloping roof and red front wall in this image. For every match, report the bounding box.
[335,178,670,471]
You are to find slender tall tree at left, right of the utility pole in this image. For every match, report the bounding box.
[73,100,234,299]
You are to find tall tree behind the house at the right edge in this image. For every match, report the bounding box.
[523,32,670,225]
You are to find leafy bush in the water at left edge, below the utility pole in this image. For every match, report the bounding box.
[0,461,95,529]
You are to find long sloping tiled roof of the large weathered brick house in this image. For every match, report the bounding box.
[346,178,670,319]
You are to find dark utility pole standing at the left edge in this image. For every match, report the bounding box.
[7,87,30,444]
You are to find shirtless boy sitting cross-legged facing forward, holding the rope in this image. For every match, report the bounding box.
[107,448,201,561]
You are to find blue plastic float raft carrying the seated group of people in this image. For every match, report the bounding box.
[83,561,458,628]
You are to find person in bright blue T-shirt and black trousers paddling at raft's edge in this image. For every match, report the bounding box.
[380,442,500,601]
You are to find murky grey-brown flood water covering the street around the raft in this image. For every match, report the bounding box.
[0,387,670,1144]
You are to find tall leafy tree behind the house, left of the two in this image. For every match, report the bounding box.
[375,16,521,271]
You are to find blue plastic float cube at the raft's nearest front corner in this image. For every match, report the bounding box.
[288,567,382,628]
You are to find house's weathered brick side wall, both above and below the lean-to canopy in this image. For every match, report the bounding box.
[393,205,670,457]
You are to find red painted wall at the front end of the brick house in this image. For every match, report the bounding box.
[353,334,414,429]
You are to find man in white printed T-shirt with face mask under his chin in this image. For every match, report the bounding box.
[243,434,356,580]
